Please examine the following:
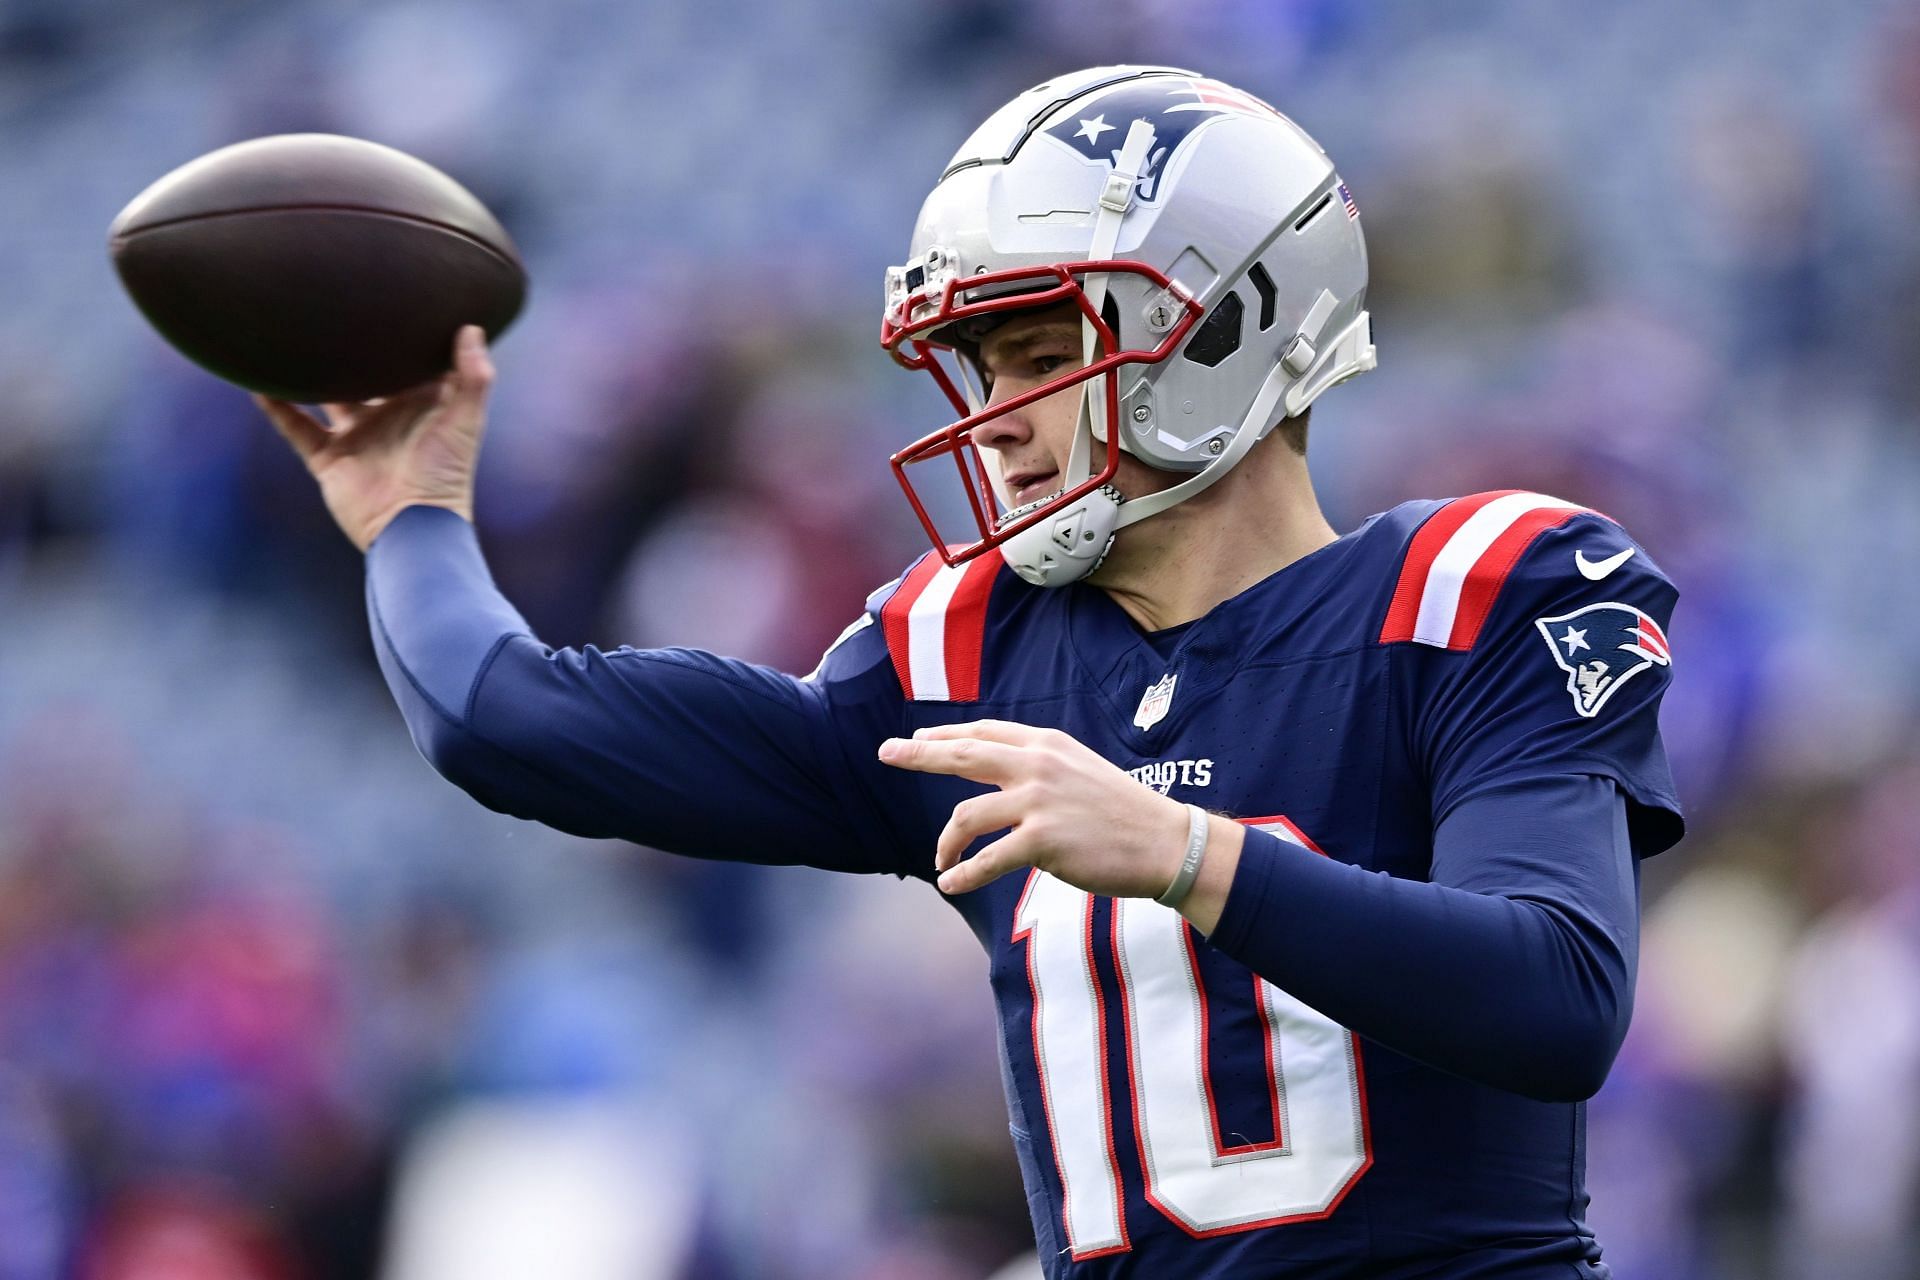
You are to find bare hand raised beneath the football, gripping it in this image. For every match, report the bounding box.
[253,324,493,551]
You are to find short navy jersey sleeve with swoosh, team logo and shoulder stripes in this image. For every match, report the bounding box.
[1380,493,1684,854]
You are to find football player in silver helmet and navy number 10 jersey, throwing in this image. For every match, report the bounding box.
[265,67,1682,1280]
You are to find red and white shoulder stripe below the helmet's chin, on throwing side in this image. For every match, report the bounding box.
[879,553,1006,702]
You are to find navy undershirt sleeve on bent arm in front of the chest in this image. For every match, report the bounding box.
[1210,775,1640,1102]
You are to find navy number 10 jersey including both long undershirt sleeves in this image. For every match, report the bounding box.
[369,493,1680,1278]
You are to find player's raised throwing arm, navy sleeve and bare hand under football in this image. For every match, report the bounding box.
[259,326,904,871]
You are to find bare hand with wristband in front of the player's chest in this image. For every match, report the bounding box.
[879,720,1205,898]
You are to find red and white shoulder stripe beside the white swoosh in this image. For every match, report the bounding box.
[1380,489,1592,649]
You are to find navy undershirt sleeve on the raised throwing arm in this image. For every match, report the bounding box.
[367,507,925,873]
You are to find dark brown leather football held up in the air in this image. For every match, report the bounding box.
[108,134,526,403]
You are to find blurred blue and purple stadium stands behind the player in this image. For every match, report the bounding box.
[0,0,1920,1280]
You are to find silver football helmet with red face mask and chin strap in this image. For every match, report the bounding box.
[881,67,1375,587]
